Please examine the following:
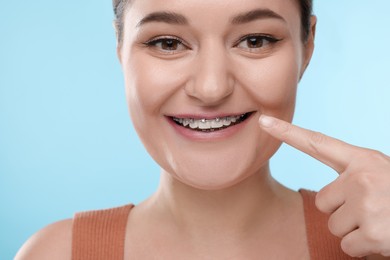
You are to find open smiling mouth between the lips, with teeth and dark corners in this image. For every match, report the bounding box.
[172,112,253,132]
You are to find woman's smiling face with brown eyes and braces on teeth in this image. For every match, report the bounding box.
[119,0,311,190]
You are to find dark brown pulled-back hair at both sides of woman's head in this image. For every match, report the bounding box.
[112,0,313,44]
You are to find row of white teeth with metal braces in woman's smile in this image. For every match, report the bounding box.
[173,114,245,130]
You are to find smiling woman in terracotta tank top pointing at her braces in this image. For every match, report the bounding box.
[12,0,390,260]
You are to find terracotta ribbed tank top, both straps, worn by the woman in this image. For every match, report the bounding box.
[72,190,360,260]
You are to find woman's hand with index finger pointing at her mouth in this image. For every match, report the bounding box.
[259,116,390,257]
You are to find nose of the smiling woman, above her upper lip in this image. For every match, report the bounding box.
[185,44,234,106]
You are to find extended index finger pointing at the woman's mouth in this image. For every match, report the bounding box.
[259,115,356,173]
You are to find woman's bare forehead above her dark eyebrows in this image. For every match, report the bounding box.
[127,0,300,29]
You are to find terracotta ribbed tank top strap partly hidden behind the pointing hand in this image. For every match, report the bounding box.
[299,190,363,260]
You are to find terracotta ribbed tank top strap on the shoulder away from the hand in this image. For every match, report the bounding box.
[72,205,133,260]
